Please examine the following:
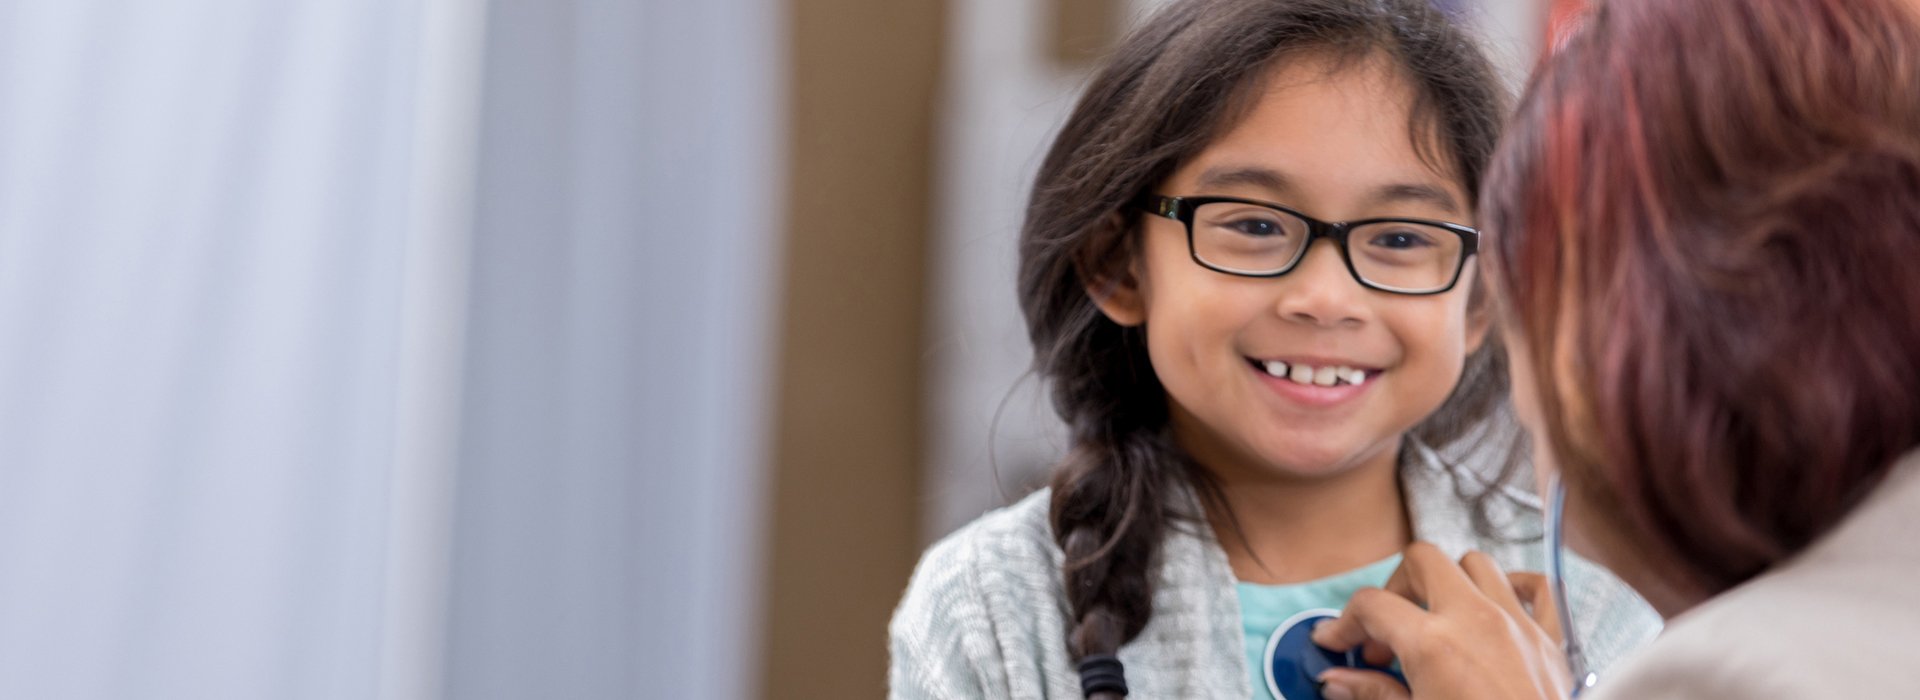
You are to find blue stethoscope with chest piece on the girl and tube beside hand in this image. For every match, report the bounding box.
[1261,478,1599,700]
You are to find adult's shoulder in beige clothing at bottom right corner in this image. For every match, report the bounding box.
[1592,453,1920,700]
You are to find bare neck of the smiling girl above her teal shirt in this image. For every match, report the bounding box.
[1208,441,1413,585]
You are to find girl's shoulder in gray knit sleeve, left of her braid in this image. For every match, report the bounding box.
[887,489,1064,700]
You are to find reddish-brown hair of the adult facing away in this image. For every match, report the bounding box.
[1480,0,1920,595]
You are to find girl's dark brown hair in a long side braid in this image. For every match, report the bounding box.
[1020,0,1505,696]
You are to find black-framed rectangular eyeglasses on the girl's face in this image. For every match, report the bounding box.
[1139,194,1480,295]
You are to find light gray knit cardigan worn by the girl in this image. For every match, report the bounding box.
[887,443,1661,700]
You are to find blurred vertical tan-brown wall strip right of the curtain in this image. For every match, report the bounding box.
[760,0,947,698]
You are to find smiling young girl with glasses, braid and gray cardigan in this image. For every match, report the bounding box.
[891,0,1659,700]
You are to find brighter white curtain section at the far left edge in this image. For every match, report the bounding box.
[0,0,419,698]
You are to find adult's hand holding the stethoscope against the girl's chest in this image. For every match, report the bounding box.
[1313,543,1572,700]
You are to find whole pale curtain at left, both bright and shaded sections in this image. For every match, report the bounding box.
[0,0,781,698]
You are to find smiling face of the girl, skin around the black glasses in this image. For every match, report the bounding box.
[1096,58,1486,481]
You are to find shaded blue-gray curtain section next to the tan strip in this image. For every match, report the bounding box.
[449,0,785,700]
